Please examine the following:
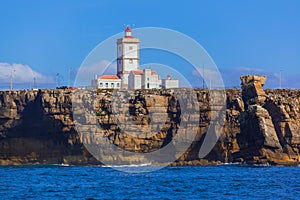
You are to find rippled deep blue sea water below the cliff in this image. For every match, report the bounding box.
[0,165,300,199]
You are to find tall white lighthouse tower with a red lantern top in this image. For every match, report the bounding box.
[117,26,140,88]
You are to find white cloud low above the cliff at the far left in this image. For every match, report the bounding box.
[0,63,54,84]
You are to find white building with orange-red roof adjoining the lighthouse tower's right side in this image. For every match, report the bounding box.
[128,69,162,89]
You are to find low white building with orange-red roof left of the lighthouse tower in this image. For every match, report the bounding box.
[92,75,121,89]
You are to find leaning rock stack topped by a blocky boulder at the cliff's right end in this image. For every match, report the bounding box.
[236,76,300,164]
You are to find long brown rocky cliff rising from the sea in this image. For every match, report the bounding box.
[0,76,300,165]
